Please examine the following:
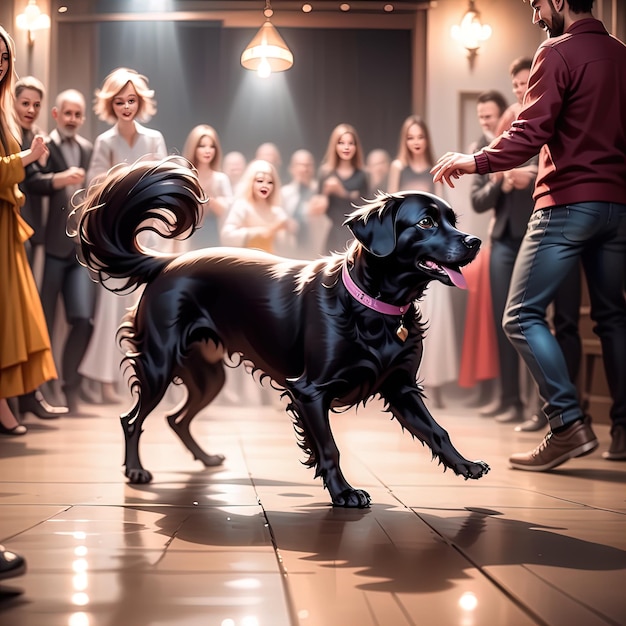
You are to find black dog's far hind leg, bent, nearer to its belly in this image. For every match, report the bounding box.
[167,354,226,467]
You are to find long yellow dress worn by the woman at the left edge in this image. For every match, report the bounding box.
[0,139,57,398]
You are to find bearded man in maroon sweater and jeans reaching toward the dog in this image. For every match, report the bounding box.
[432,0,626,471]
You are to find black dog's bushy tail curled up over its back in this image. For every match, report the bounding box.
[70,157,206,292]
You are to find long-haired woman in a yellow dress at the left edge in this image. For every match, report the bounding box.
[0,26,57,435]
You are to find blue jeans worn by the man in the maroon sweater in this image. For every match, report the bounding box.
[503,202,626,429]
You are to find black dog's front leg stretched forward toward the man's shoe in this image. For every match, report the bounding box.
[382,386,489,479]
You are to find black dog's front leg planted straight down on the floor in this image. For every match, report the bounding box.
[288,398,370,509]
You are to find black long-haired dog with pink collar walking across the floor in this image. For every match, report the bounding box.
[78,157,489,507]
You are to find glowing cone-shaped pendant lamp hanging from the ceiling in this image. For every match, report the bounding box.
[241,0,293,78]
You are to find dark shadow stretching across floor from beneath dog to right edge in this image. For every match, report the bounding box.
[120,475,626,594]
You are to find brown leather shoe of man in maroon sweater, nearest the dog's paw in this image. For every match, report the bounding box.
[509,418,598,472]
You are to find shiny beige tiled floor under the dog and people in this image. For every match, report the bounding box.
[0,388,626,626]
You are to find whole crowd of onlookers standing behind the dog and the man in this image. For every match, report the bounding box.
[0,37,580,435]
